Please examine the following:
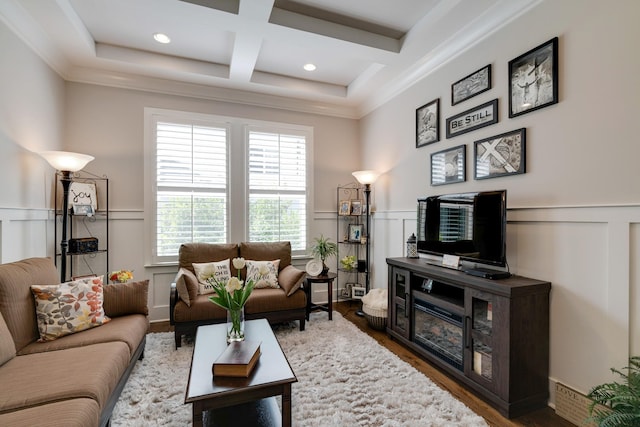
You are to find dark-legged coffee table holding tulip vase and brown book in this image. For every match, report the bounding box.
[184,319,298,427]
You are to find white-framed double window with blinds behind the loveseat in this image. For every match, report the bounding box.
[145,109,312,263]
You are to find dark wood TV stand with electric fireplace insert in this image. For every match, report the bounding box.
[387,258,551,418]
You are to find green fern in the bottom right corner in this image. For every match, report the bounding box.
[588,356,640,427]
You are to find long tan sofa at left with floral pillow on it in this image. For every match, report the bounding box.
[0,258,149,427]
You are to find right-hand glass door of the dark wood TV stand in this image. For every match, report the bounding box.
[466,290,495,388]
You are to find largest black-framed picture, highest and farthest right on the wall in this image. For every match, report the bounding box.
[509,37,558,117]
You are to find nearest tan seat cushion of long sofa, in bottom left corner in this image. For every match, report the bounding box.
[0,398,100,427]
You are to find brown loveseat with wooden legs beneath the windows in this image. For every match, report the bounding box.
[170,242,307,348]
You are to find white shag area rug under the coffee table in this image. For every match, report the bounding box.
[111,312,487,427]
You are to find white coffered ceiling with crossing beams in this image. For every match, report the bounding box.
[0,0,542,117]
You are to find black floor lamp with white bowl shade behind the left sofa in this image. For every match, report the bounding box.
[40,151,94,282]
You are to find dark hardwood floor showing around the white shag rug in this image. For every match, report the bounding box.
[150,302,575,427]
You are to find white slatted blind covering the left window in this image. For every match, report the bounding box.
[156,122,228,257]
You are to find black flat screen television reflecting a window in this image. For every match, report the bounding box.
[417,190,507,267]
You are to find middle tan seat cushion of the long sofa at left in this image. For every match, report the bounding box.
[0,341,131,412]
